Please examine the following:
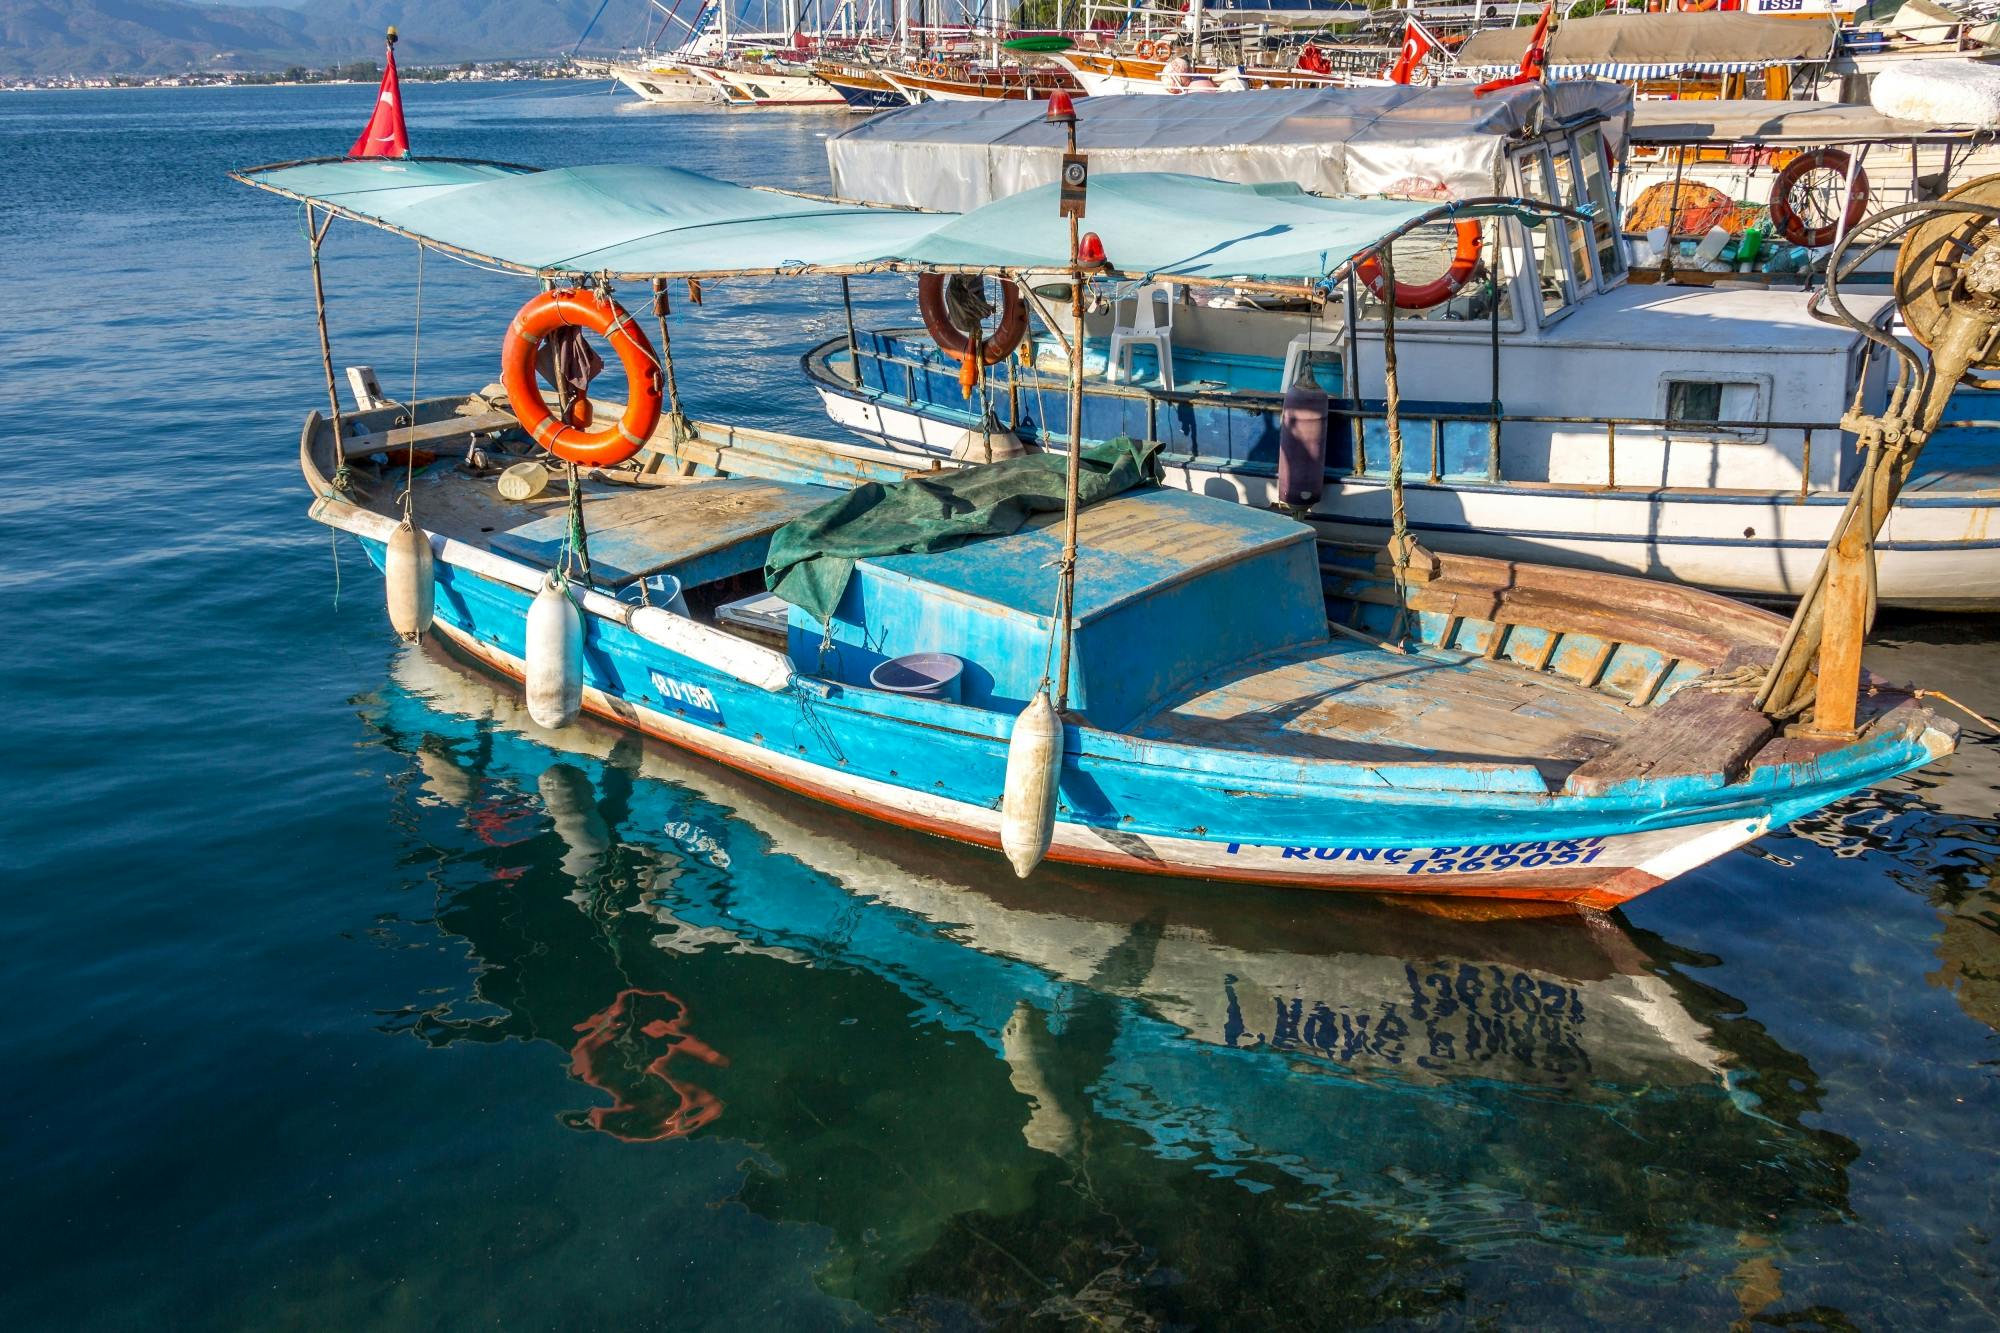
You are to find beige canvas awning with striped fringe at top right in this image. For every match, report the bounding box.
[1458,12,1840,80]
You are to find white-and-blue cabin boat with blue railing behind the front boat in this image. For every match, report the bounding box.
[802,82,2000,610]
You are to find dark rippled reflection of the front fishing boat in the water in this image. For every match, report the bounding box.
[366,650,1856,1325]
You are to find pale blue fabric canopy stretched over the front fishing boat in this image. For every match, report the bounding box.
[236,160,1494,286]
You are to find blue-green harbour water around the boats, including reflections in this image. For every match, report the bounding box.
[0,84,2000,1329]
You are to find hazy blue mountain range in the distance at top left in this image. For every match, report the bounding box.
[0,0,694,78]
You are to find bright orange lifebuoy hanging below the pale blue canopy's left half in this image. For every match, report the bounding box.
[500,288,660,468]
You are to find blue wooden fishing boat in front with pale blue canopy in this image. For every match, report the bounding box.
[230,150,1954,907]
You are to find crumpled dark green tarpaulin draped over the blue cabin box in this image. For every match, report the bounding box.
[764,436,1160,624]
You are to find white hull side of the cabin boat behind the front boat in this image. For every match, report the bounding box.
[816,384,2000,610]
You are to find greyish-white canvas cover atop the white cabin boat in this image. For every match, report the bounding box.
[826,82,1632,210]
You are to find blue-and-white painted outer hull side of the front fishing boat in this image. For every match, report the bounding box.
[364,542,1950,907]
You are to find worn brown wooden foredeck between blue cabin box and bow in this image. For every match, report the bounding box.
[1132,640,1640,785]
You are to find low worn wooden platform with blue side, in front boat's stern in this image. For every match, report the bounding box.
[490,478,842,588]
